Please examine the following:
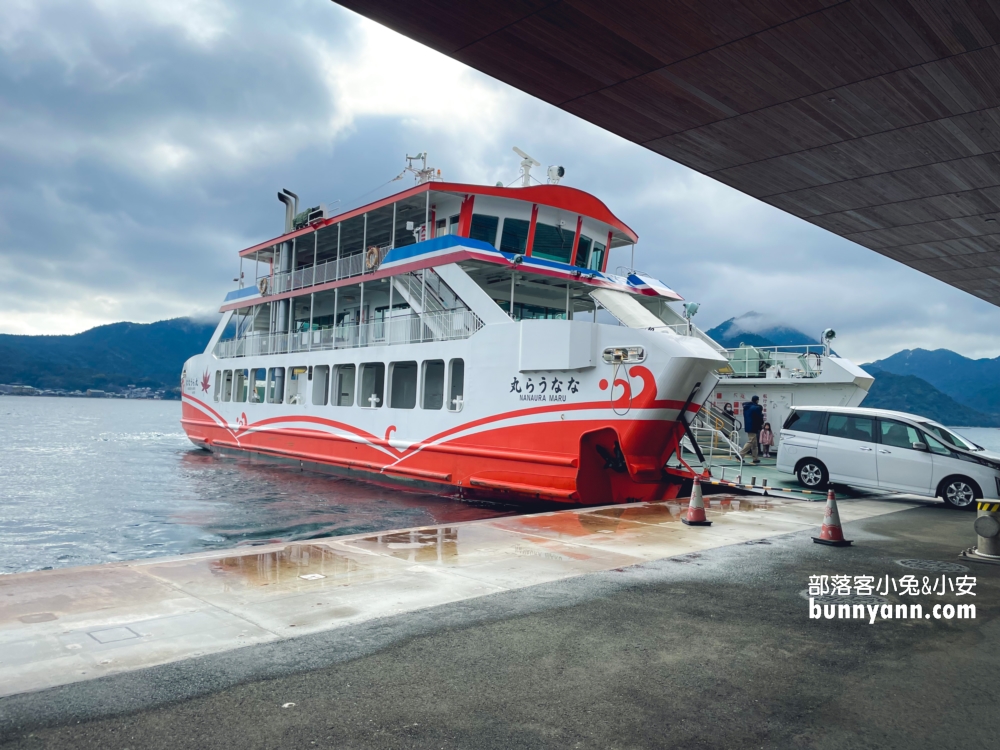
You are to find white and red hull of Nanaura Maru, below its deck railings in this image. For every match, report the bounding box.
[182,325,719,505]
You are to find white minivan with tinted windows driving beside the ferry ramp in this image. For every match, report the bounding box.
[777,406,1000,508]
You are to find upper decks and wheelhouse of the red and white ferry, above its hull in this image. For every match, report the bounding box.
[214,179,687,402]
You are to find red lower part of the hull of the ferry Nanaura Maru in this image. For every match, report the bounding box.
[182,401,696,505]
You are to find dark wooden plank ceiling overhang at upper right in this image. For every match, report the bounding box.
[338,0,1000,304]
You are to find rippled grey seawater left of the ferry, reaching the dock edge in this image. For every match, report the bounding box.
[0,396,524,573]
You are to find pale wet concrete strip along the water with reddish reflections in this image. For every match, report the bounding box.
[0,495,913,696]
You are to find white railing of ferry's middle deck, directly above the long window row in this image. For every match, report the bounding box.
[215,310,483,359]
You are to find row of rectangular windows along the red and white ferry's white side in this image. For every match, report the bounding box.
[214,359,465,411]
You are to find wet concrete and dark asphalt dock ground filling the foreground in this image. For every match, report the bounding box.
[0,495,1000,748]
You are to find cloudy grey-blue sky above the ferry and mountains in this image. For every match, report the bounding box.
[0,0,1000,361]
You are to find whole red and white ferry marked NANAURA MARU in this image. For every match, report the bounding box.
[182,154,727,504]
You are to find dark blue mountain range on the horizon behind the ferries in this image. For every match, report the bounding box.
[0,312,1000,427]
